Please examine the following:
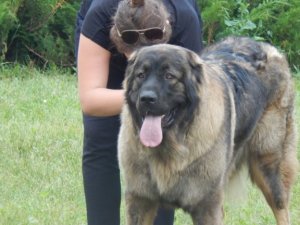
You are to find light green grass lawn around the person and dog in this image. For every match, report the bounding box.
[0,65,300,225]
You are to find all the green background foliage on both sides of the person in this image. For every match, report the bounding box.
[0,0,300,69]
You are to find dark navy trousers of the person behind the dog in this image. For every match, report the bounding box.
[82,115,174,225]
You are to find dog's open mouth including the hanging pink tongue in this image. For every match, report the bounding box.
[140,109,177,148]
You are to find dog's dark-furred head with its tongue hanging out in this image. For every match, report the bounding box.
[124,44,202,147]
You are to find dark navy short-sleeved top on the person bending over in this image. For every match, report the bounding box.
[79,0,203,89]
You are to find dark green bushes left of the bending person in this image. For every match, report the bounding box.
[0,0,80,66]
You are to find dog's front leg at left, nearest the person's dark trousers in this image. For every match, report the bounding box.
[125,193,158,225]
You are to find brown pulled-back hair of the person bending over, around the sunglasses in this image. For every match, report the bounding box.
[110,0,172,53]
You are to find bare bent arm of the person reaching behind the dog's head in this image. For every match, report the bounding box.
[78,34,124,116]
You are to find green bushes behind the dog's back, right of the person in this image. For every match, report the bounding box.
[197,0,300,67]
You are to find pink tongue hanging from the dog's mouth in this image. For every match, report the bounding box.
[140,116,162,148]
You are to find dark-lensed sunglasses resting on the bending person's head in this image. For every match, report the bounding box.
[116,26,166,44]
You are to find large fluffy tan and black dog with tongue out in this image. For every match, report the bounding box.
[119,38,297,225]
